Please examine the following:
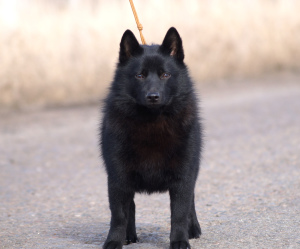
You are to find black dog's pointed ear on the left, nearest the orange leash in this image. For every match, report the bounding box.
[119,29,144,64]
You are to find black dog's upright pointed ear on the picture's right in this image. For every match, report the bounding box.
[159,27,184,62]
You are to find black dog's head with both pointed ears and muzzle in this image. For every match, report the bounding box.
[115,27,189,112]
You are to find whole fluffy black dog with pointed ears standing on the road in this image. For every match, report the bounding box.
[101,28,201,249]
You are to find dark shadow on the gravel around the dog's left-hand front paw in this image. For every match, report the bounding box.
[56,222,170,249]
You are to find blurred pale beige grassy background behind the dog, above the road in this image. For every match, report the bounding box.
[0,0,300,109]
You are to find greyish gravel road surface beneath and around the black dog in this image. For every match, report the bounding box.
[0,77,300,249]
